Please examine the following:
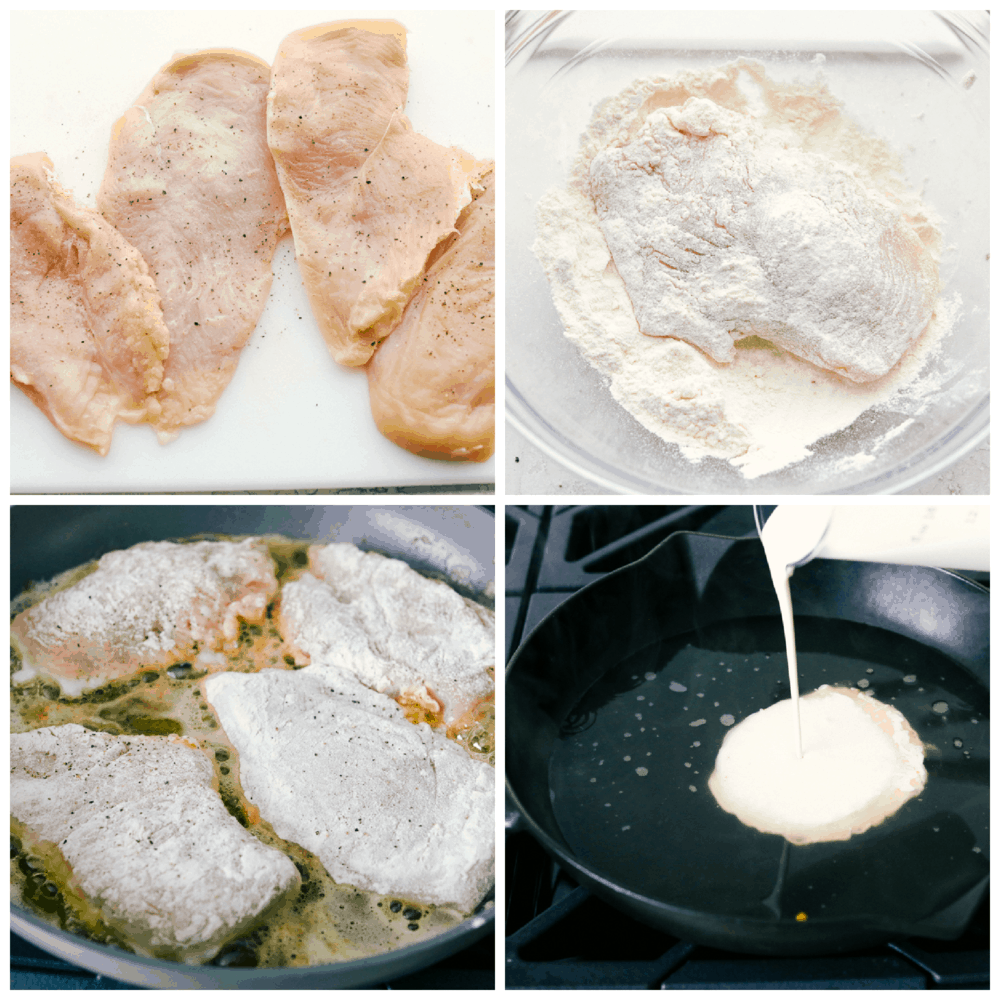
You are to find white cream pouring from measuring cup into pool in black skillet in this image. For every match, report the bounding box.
[708,505,976,844]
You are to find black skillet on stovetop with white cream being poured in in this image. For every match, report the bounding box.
[506,532,989,955]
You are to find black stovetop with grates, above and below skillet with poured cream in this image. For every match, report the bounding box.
[505,505,989,989]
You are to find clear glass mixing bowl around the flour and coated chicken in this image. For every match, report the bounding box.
[505,11,989,494]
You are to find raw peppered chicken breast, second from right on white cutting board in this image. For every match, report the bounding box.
[267,21,481,365]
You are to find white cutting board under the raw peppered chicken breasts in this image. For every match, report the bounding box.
[10,11,495,493]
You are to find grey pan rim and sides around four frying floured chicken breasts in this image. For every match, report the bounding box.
[11,505,495,989]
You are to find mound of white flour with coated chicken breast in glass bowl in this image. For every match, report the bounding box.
[534,60,958,478]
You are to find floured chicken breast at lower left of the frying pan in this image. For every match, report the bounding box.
[10,725,301,963]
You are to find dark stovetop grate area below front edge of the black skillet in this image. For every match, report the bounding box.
[505,833,989,990]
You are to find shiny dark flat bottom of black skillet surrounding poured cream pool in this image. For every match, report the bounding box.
[548,616,989,928]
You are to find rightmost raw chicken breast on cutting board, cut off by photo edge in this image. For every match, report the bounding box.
[368,169,496,462]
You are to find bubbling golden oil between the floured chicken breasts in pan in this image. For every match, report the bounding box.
[10,535,496,967]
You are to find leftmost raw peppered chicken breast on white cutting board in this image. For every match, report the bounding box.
[10,153,169,455]
